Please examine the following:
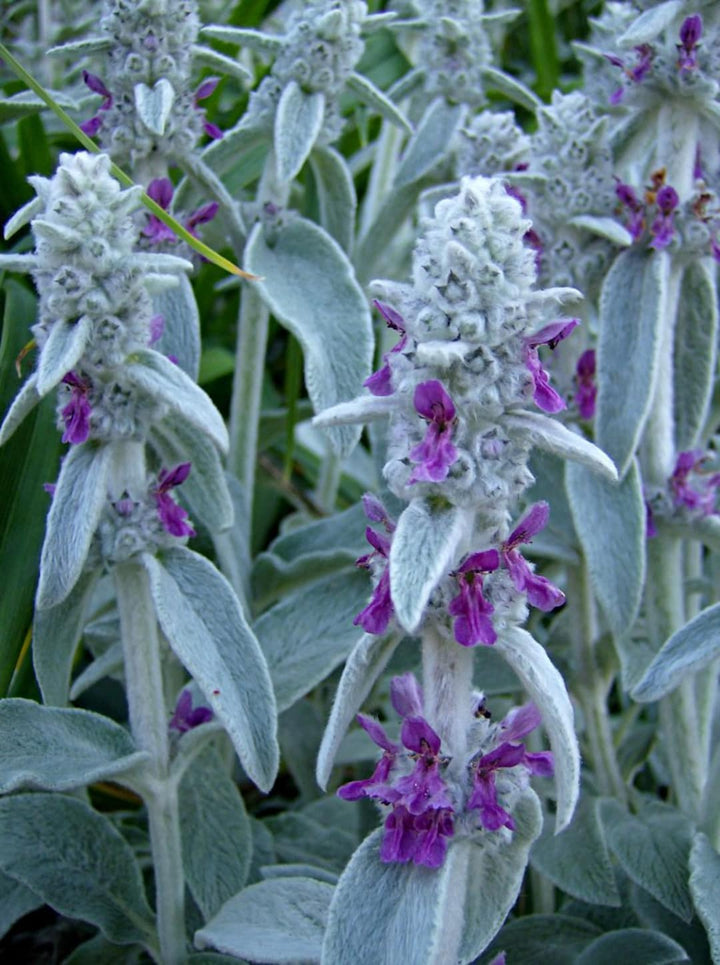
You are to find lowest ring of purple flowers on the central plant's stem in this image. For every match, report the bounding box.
[338,673,553,868]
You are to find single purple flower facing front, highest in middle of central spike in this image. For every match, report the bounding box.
[408,379,457,483]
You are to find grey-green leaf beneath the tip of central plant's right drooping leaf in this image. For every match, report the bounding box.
[531,795,620,907]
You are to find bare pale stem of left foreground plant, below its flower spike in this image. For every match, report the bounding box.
[115,562,187,965]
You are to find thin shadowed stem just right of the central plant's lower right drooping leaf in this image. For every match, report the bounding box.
[568,562,627,803]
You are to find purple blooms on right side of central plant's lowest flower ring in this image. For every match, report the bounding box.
[467,704,553,831]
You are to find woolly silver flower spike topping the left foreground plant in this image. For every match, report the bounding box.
[0,153,225,588]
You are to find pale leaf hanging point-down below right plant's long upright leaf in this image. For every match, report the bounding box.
[565,460,646,636]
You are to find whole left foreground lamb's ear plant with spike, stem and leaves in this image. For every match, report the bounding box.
[0,147,278,962]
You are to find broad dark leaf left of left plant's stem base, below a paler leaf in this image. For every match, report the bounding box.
[0,793,154,947]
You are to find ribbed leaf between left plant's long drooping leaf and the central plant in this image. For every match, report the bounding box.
[254,569,369,712]
